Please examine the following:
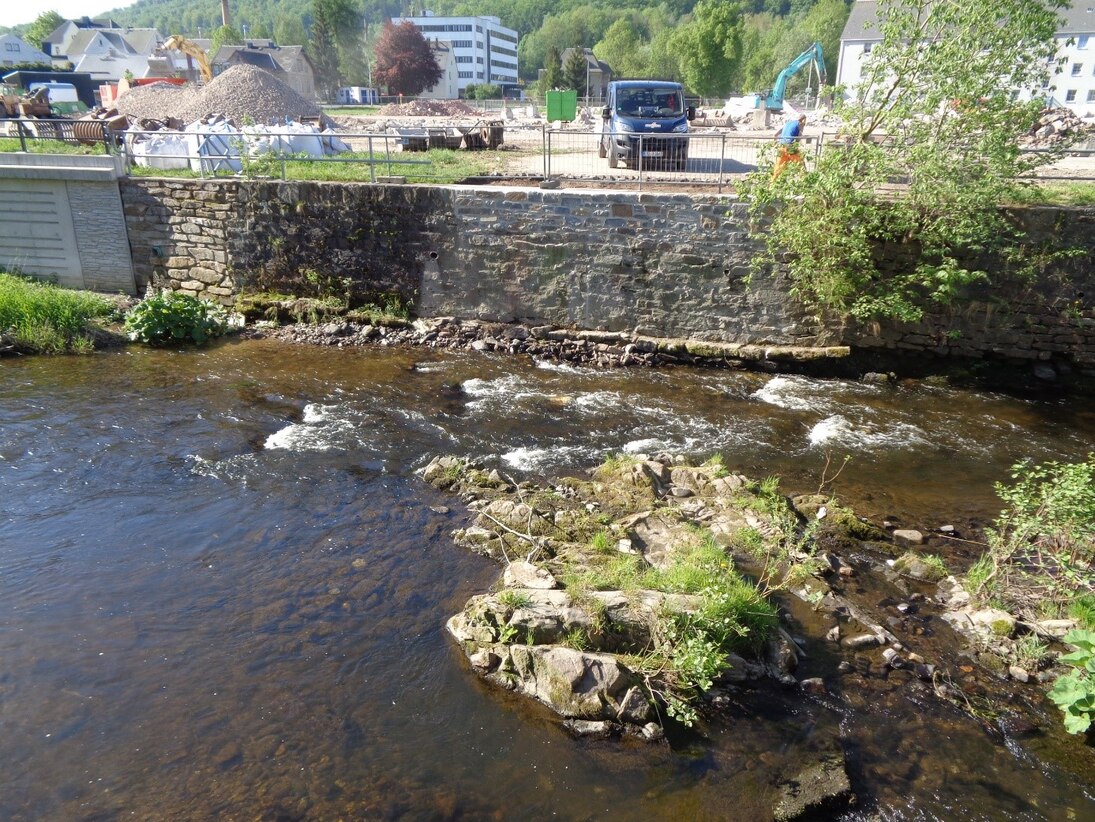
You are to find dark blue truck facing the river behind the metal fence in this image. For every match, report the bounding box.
[598,80,695,171]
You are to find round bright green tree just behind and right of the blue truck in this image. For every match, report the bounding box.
[670,0,742,97]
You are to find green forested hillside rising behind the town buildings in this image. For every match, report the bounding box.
[102,0,850,96]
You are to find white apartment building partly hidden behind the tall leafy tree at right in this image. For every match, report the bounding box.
[837,0,1095,117]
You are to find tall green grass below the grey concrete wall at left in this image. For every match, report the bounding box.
[0,271,114,354]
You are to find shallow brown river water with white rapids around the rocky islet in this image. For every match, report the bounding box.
[0,340,1095,820]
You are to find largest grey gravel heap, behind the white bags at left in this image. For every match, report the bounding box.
[116,66,320,125]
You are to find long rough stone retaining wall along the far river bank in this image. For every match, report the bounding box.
[115,178,1095,367]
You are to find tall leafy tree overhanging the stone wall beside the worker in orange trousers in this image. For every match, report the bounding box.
[739,0,1064,321]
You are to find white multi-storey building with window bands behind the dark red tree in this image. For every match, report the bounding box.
[392,12,518,92]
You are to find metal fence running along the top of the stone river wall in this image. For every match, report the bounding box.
[0,119,1095,186]
